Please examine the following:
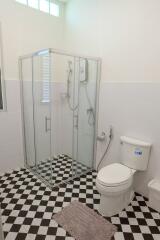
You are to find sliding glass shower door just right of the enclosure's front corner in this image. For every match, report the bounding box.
[51,53,75,185]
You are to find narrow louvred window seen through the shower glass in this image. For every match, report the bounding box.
[42,54,50,103]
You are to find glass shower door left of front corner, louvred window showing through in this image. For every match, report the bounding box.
[33,51,52,181]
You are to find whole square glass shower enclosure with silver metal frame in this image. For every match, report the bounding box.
[19,49,100,187]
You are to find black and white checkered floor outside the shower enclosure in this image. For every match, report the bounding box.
[0,169,160,240]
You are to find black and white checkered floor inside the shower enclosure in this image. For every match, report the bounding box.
[32,155,90,186]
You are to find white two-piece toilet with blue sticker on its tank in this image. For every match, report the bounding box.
[96,136,151,216]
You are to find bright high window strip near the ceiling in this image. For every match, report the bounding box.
[15,0,60,17]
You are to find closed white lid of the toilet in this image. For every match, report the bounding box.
[97,163,134,186]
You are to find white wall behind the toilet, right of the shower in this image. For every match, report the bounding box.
[66,0,160,196]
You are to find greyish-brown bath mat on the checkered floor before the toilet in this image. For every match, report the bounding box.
[53,201,116,240]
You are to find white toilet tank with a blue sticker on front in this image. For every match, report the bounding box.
[120,136,151,171]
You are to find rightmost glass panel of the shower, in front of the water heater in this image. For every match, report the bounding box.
[73,58,98,175]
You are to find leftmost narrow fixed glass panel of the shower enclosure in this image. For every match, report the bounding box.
[21,58,36,168]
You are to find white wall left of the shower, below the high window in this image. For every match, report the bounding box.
[0,0,64,172]
